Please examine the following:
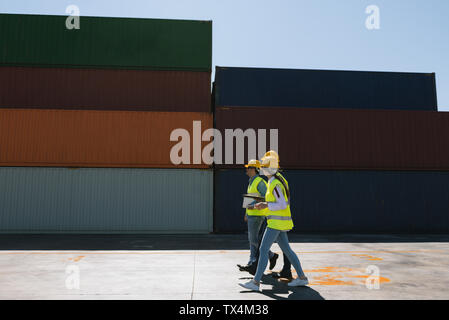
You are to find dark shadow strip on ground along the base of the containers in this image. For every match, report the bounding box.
[0,234,449,250]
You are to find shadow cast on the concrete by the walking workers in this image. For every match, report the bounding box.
[240,275,324,300]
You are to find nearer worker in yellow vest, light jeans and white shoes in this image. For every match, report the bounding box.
[239,151,309,291]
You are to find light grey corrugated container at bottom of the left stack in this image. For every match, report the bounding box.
[0,167,213,233]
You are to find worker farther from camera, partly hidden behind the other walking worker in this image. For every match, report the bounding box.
[237,160,279,271]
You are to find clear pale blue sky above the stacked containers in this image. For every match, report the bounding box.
[0,0,449,111]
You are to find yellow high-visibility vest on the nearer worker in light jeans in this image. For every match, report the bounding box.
[265,176,293,230]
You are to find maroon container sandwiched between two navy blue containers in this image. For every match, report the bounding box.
[215,107,449,170]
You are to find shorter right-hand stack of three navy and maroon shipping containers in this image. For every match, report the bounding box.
[214,68,449,233]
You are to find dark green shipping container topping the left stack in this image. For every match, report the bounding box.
[0,14,212,71]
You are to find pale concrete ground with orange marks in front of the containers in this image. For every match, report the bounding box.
[0,235,449,300]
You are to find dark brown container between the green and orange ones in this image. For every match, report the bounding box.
[0,67,211,112]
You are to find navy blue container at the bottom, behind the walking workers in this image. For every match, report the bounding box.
[214,169,449,233]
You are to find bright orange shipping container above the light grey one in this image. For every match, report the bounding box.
[0,109,212,168]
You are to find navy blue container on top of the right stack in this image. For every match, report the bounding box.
[215,67,437,111]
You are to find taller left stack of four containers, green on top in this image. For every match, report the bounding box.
[0,14,213,233]
